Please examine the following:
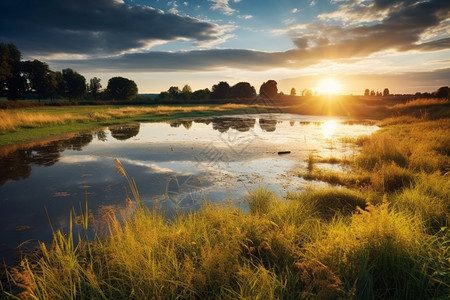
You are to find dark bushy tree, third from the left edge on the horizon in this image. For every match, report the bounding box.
[56,68,86,101]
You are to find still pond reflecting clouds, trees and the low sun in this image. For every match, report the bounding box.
[0,114,378,261]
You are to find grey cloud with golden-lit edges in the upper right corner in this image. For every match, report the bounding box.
[291,0,450,59]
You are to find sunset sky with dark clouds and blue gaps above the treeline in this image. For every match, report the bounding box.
[0,0,450,95]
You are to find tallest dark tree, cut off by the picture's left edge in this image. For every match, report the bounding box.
[0,43,26,100]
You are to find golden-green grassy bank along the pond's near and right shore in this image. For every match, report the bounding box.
[3,103,450,299]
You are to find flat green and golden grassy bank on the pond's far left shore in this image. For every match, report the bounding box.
[0,104,278,146]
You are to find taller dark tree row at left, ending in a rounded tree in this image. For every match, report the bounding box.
[0,43,138,101]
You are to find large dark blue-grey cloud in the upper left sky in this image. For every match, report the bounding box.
[0,0,220,55]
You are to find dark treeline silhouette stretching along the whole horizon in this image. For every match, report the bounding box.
[0,43,450,104]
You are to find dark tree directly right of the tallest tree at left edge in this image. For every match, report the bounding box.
[22,59,57,101]
